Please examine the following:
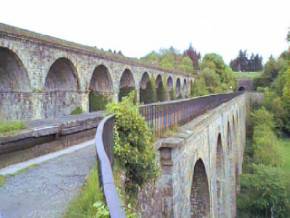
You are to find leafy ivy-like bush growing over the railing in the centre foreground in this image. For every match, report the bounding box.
[107,92,158,194]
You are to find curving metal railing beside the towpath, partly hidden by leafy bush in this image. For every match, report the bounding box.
[96,93,241,218]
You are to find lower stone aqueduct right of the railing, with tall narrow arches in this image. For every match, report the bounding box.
[140,94,248,218]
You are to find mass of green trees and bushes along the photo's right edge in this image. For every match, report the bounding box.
[238,50,290,218]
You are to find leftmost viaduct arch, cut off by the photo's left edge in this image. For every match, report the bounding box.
[0,47,33,120]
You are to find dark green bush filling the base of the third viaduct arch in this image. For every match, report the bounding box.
[89,92,112,111]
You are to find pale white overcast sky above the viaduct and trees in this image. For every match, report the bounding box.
[0,0,290,62]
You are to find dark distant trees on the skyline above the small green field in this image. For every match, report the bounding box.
[230,50,263,72]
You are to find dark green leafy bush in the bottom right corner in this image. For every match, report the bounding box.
[237,165,289,218]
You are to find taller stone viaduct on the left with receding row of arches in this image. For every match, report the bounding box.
[0,24,193,120]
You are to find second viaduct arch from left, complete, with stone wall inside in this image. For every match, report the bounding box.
[43,58,81,118]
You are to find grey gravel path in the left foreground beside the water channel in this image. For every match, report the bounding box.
[0,145,96,218]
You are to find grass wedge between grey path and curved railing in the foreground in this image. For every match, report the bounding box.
[64,167,104,218]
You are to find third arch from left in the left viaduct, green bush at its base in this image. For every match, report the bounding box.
[89,65,113,112]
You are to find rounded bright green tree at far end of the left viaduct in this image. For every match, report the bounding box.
[191,53,236,96]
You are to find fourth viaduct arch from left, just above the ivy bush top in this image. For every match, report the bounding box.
[118,69,135,101]
